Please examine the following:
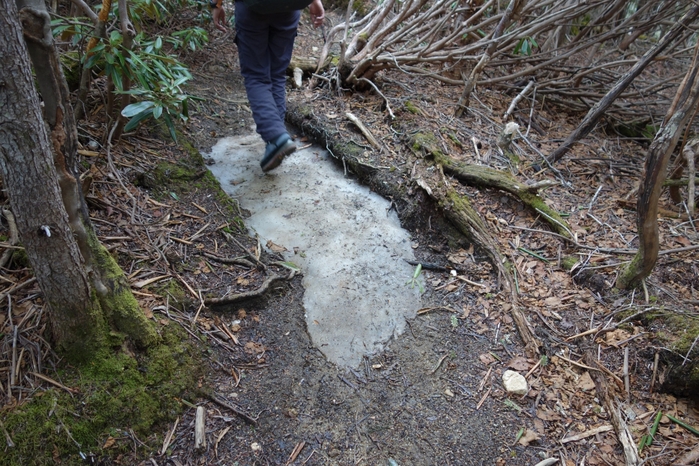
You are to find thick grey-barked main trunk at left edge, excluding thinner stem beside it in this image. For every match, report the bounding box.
[0,0,105,360]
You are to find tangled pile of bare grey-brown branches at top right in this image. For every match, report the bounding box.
[319,0,696,127]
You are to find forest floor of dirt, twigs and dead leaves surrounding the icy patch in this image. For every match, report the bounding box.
[0,6,699,466]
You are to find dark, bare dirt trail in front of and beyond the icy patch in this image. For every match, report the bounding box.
[171,16,540,465]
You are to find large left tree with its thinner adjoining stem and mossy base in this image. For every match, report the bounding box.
[0,0,157,361]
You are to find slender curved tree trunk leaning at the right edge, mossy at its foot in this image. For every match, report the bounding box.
[616,39,699,289]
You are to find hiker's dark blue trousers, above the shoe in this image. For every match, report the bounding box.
[235,1,301,141]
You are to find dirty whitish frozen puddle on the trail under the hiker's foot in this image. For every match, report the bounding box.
[209,134,420,367]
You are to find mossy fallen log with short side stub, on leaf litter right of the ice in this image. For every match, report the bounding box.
[413,135,573,239]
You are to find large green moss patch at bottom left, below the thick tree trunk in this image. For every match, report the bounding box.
[1,326,202,466]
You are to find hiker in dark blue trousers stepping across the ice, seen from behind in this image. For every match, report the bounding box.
[211,0,325,172]
